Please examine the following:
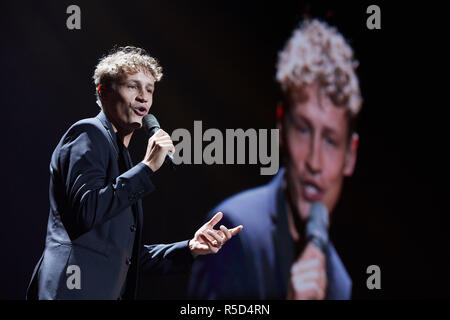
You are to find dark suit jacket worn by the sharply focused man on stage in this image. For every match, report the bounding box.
[27,112,192,299]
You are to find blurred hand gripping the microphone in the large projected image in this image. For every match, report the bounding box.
[287,243,327,300]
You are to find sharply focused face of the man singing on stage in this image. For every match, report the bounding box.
[102,71,155,133]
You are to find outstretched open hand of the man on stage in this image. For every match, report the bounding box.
[189,212,243,258]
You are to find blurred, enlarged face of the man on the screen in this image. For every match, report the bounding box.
[281,84,358,220]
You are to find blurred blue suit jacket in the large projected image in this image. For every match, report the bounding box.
[189,168,352,300]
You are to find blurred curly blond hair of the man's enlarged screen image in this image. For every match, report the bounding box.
[276,19,362,116]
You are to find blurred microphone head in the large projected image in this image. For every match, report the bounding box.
[306,202,329,253]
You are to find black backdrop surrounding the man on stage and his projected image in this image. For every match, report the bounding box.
[0,0,450,299]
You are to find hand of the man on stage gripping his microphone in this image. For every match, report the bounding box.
[142,129,175,172]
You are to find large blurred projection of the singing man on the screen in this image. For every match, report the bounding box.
[190,20,362,300]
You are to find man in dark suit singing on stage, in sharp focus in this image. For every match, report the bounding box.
[27,47,242,299]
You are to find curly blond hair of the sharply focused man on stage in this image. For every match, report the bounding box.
[92,46,163,107]
